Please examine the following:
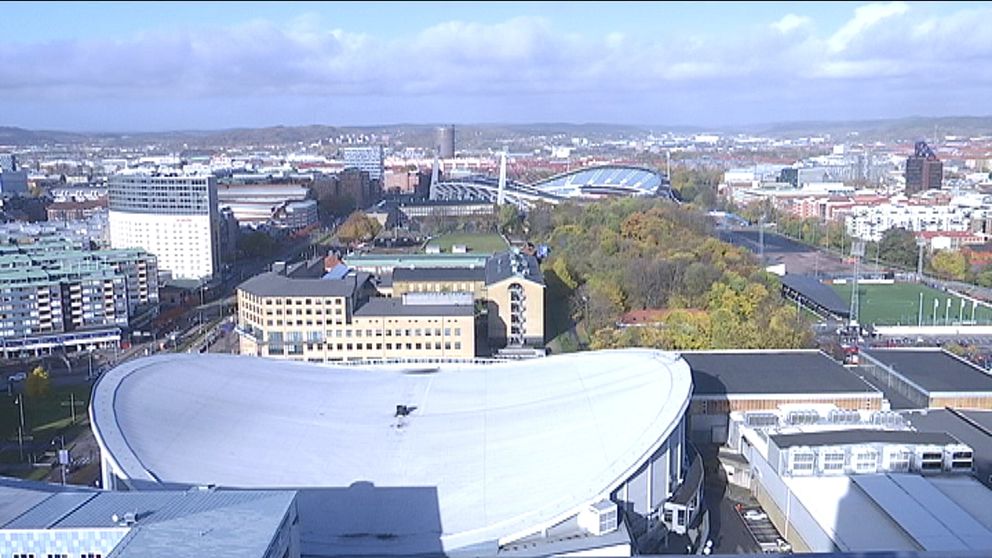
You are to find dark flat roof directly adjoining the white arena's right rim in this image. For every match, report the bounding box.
[682,350,881,396]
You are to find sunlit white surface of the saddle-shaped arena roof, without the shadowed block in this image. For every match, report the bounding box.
[90,349,692,549]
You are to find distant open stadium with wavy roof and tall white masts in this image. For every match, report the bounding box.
[431,165,674,209]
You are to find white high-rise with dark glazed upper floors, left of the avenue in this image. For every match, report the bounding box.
[109,174,220,280]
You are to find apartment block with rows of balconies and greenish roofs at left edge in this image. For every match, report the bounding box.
[0,237,158,358]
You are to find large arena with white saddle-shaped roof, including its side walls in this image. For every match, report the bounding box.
[90,349,702,556]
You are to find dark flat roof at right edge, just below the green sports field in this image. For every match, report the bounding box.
[863,349,992,394]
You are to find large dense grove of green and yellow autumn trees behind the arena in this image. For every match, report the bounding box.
[536,198,812,350]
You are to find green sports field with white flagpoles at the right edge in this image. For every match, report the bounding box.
[831,283,992,325]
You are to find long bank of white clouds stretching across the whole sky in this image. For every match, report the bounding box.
[0,2,992,124]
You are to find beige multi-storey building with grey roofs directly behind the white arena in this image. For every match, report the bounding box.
[238,262,475,362]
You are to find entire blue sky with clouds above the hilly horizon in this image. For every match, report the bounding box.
[0,2,992,132]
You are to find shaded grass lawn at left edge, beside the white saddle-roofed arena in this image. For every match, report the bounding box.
[0,384,90,441]
